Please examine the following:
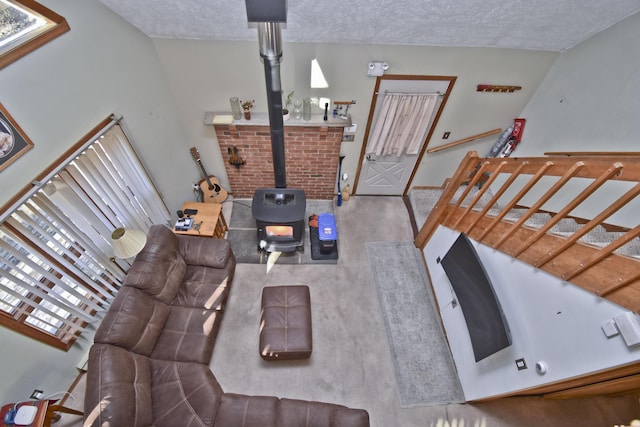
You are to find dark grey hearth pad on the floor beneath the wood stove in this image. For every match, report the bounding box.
[227,199,340,264]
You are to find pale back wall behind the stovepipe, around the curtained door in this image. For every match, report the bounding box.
[153,40,557,194]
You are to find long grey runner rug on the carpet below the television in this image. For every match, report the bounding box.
[367,241,464,407]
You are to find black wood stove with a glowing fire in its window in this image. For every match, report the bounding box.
[251,188,307,252]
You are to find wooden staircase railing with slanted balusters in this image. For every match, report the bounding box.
[415,152,640,312]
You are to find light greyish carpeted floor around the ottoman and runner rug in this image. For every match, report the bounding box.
[57,197,640,427]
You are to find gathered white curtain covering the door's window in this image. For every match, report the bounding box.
[367,93,440,157]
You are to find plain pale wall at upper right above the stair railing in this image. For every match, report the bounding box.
[516,13,640,157]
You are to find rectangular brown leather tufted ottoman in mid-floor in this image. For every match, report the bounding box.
[260,285,312,360]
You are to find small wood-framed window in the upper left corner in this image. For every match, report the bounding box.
[0,0,69,69]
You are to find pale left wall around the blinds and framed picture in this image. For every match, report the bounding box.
[0,0,191,402]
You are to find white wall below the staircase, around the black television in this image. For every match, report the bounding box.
[423,227,640,400]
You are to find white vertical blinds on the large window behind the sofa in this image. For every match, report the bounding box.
[0,119,170,346]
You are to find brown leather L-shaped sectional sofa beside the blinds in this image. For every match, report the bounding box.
[85,225,369,427]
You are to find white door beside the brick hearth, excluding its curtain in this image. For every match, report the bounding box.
[356,76,452,196]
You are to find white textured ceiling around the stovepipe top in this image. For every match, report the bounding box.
[101,0,640,51]
